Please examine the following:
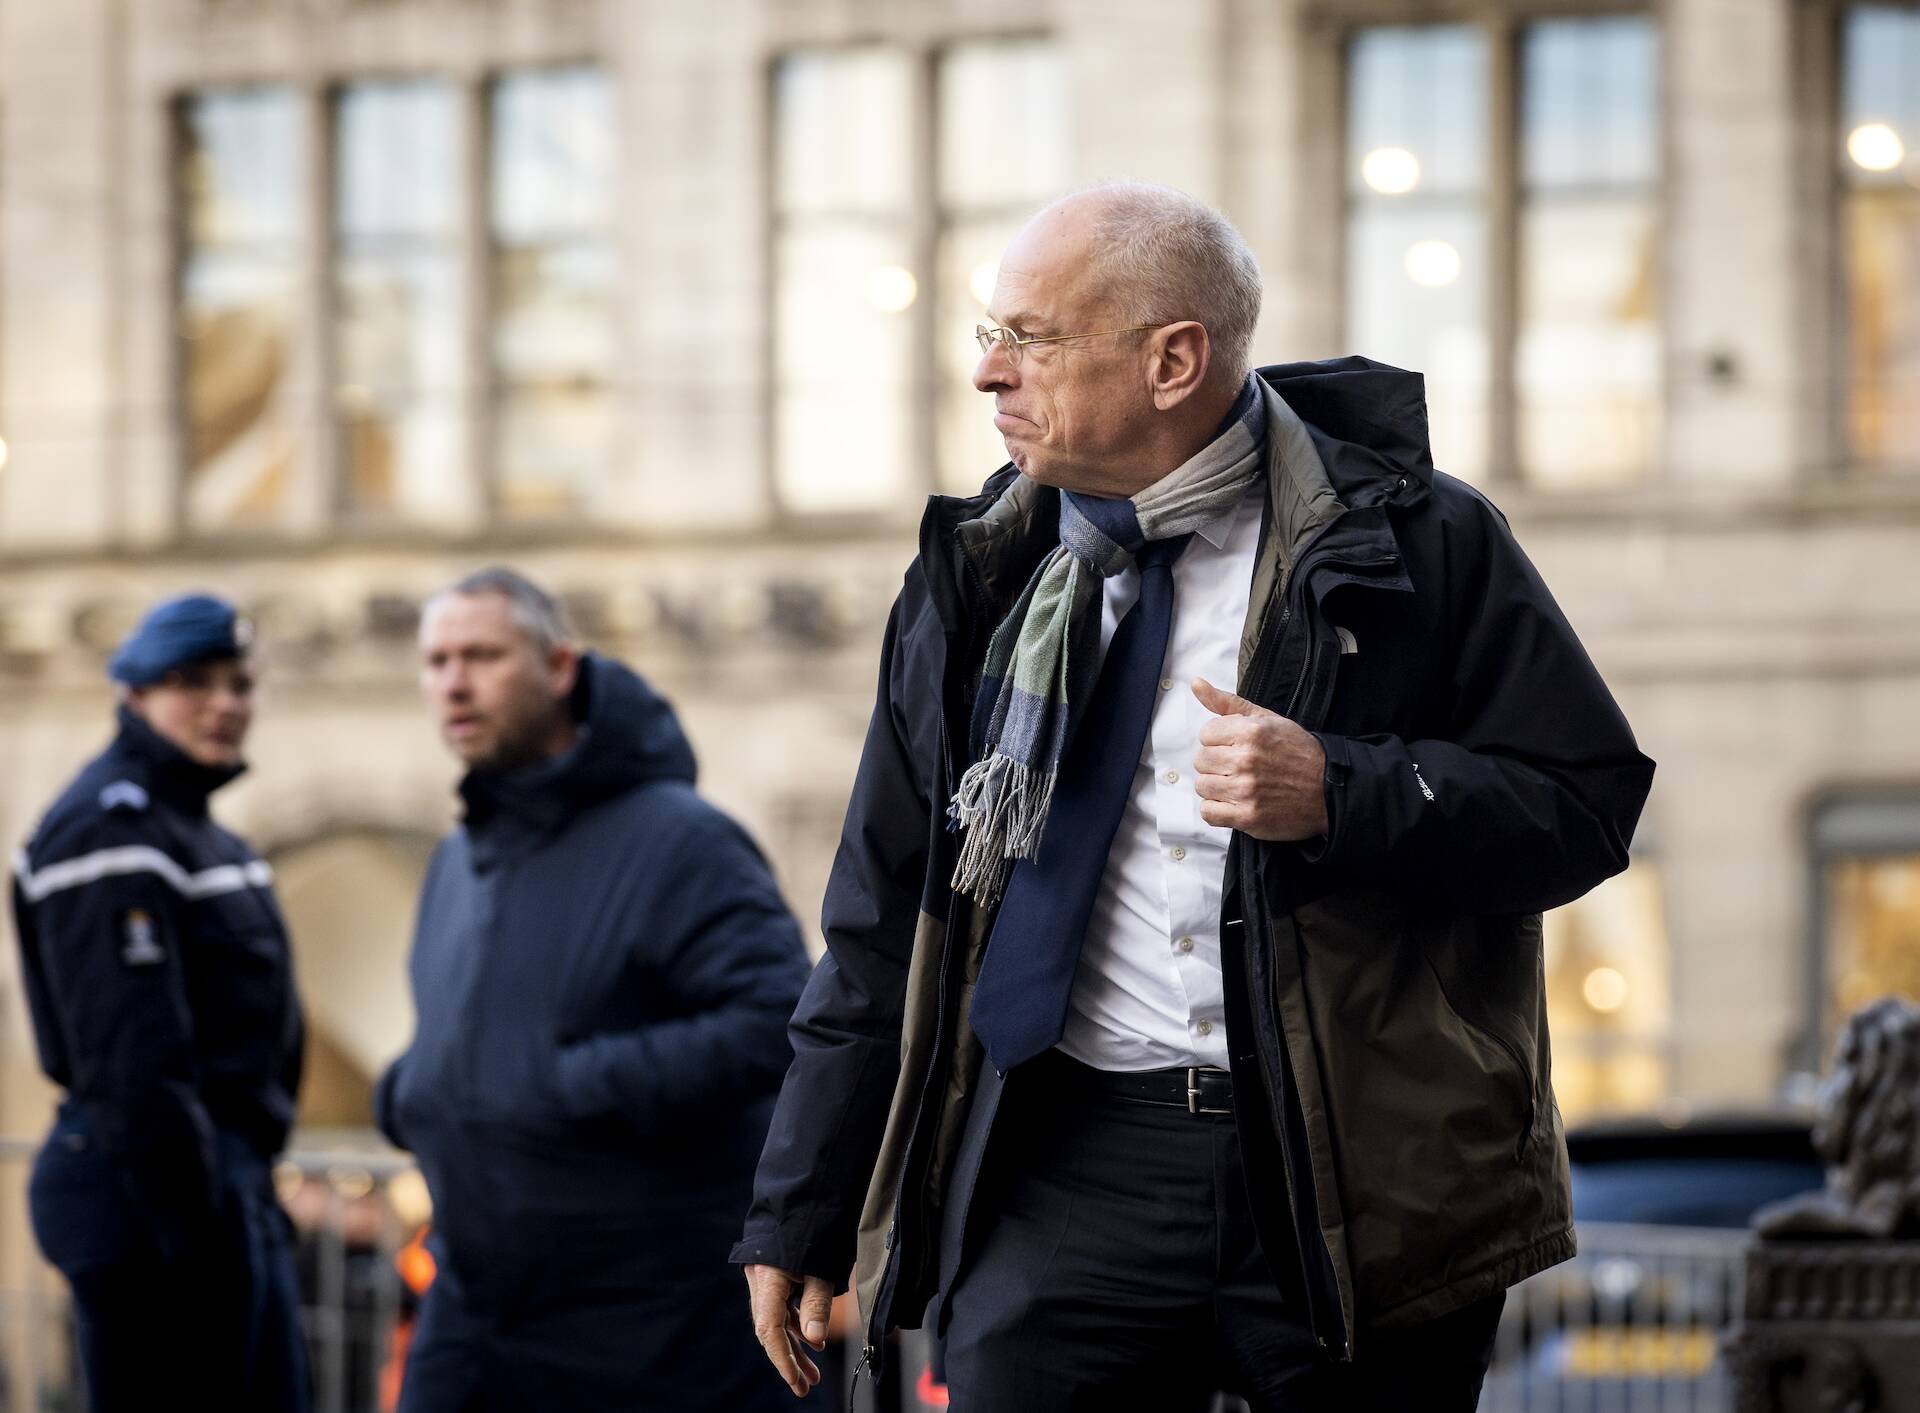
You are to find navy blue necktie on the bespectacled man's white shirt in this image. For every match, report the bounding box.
[972,526,1192,1075]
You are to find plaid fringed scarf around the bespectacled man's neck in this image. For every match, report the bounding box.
[947,374,1267,906]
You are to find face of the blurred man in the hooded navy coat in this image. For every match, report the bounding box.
[420,593,578,770]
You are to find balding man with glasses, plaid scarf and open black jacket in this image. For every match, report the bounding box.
[733,184,1653,1413]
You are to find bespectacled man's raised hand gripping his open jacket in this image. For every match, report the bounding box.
[1194,678,1327,843]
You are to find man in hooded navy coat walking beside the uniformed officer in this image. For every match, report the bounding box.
[376,568,806,1413]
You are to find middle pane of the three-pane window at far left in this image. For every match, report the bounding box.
[334,83,465,522]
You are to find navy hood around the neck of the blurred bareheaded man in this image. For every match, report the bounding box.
[461,653,697,848]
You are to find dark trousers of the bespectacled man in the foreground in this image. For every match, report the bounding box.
[945,1056,1505,1413]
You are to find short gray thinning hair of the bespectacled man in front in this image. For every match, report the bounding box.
[1052,180,1261,382]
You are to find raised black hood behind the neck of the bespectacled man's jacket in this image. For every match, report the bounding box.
[1256,355,1434,509]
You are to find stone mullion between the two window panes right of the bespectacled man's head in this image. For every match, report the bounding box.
[1484,13,1521,484]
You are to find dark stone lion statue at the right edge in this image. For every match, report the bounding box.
[1753,998,1920,1238]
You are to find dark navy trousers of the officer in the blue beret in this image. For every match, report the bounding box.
[29,1104,311,1413]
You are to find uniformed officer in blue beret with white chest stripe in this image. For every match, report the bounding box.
[13,595,309,1413]
